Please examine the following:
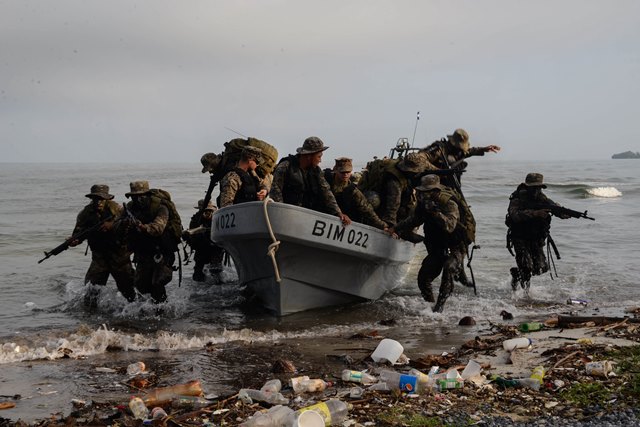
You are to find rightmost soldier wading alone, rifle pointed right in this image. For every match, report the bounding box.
[505,172,569,292]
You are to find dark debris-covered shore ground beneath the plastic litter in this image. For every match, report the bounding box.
[0,310,640,426]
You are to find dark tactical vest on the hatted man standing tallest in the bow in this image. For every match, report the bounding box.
[282,155,325,212]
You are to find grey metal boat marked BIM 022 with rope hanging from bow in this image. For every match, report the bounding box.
[211,200,415,316]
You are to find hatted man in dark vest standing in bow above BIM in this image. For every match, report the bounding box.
[270,136,351,225]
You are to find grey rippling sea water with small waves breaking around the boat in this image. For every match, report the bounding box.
[0,158,640,419]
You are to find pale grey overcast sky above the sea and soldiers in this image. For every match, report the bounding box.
[0,0,640,166]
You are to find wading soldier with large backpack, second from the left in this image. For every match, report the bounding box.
[125,181,181,303]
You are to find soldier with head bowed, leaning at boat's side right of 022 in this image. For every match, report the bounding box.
[376,153,427,227]
